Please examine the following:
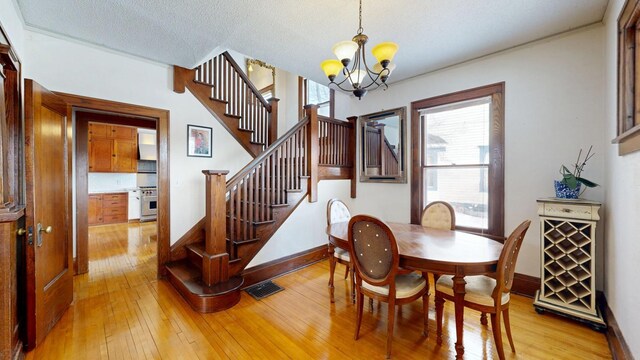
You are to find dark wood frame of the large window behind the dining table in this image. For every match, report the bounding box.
[410,82,505,237]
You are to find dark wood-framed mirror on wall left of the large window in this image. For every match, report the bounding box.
[359,107,407,183]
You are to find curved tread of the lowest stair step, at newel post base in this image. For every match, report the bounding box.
[166,259,244,297]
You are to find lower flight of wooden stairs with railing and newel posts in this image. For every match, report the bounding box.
[166,105,319,312]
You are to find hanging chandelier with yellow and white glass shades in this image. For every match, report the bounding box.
[320,0,398,99]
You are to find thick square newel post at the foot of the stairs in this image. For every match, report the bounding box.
[202,170,229,286]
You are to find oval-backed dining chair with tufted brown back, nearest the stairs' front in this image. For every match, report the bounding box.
[348,215,429,359]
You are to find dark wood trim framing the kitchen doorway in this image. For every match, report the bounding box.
[55,92,171,277]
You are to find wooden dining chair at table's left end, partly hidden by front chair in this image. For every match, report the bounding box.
[327,199,355,303]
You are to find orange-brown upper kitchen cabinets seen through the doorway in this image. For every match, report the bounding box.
[88,123,138,173]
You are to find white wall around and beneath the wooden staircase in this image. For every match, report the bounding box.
[17,31,356,265]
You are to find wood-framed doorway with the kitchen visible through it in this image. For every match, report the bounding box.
[57,93,170,276]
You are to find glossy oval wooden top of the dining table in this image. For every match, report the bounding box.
[327,222,502,265]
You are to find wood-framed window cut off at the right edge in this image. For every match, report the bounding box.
[613,0,640,155]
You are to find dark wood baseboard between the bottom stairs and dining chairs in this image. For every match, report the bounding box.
[242,245,327,288]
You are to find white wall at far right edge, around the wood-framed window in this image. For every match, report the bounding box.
[603,0,640,358]
